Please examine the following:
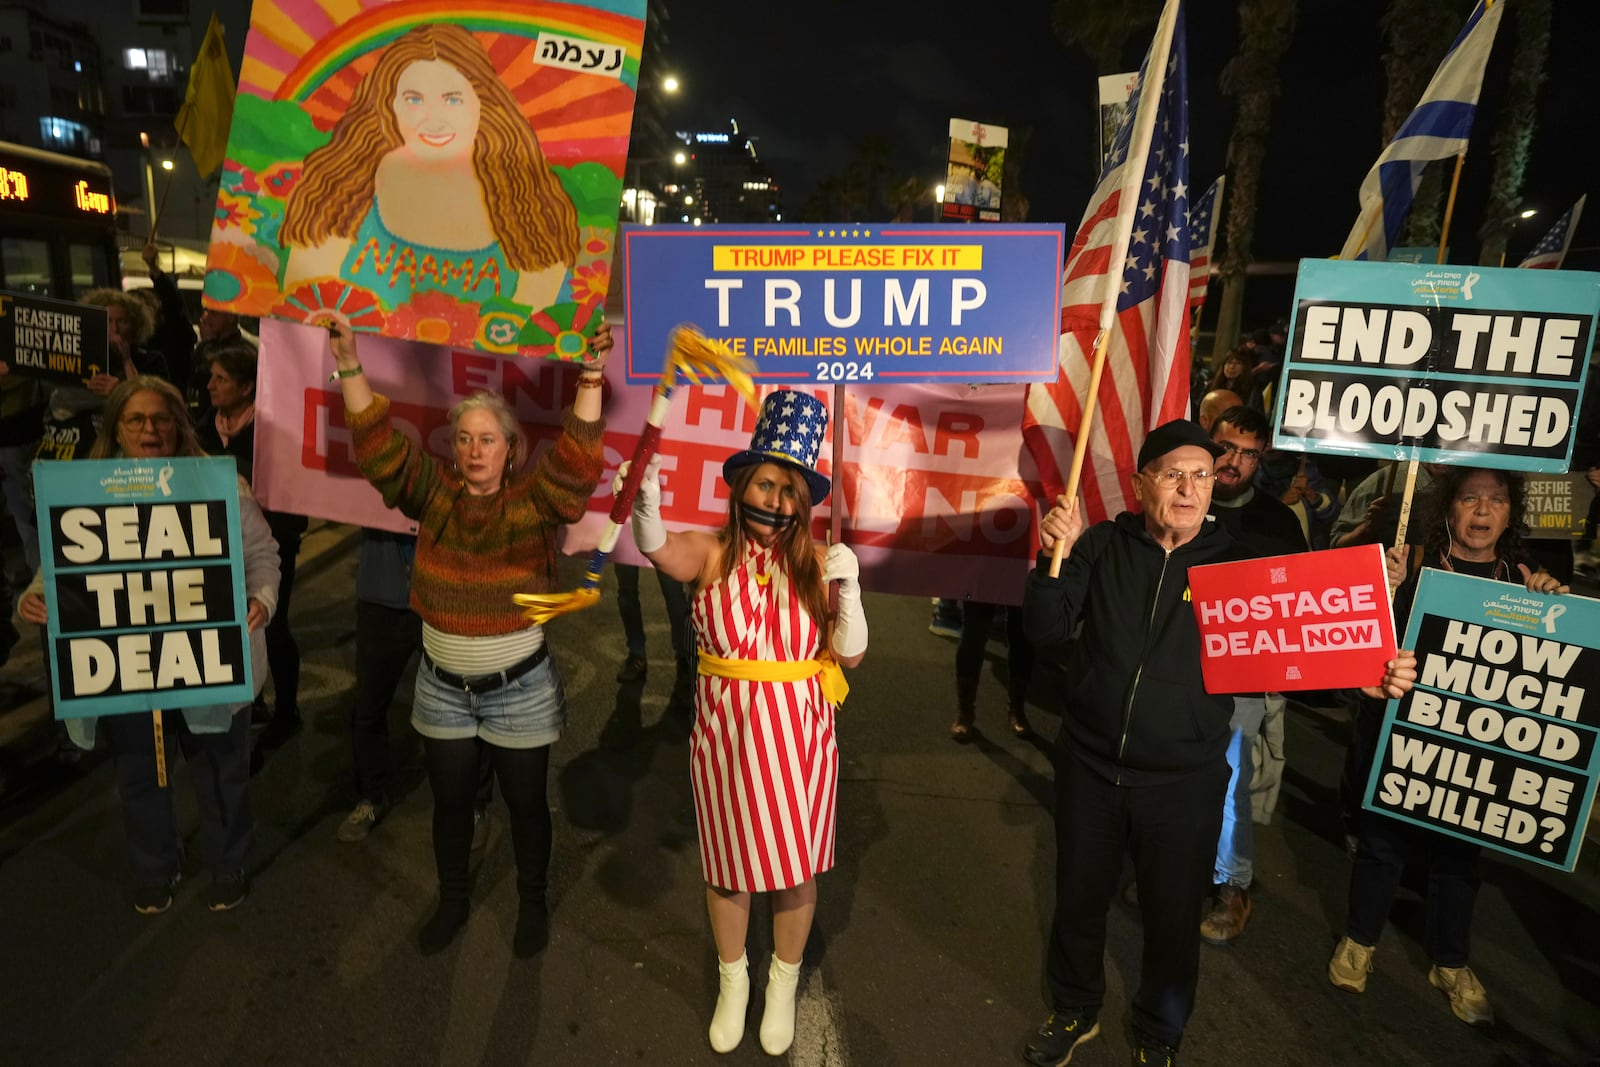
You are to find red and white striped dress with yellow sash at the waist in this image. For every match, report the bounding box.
[690,544,838,893]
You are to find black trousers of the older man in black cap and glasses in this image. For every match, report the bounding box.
[1045,752,1229,1048]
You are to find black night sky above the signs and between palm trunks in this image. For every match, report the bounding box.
[666,0,1600,325]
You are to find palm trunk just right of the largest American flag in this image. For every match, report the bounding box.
[1216,0,1299,361]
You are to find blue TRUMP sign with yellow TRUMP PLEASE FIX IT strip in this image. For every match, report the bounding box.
[622,224,1066,384]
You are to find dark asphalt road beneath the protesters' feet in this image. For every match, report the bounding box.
[0,528,1600,1067]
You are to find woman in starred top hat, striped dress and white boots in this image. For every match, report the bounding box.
[618,392,867,1056]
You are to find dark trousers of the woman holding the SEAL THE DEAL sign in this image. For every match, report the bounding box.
[99,710,254,886]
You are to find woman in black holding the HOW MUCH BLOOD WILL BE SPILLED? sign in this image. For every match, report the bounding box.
[1328,467,1568,1025]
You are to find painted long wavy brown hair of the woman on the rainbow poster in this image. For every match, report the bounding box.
[278,22,578,270]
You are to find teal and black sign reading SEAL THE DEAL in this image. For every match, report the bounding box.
[34,458,254,718]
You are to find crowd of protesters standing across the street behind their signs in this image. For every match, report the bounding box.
[0,286,1600,1065]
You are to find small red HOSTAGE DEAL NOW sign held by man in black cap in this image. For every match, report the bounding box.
[1189,544,1395,693]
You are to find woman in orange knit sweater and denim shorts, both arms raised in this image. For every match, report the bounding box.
[333,326,611,958]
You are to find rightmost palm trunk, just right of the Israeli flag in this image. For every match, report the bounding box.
[1478,0,1550,266]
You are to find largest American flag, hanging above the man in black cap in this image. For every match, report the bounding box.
[1022,0,1189,522]
